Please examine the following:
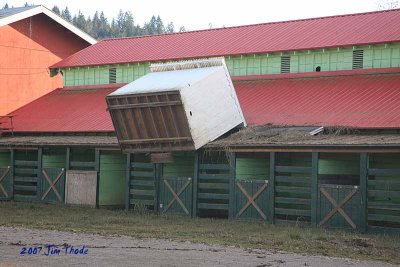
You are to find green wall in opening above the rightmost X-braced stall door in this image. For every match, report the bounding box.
[318,153,360,175]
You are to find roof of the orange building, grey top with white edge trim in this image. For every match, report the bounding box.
[0,5,97,44]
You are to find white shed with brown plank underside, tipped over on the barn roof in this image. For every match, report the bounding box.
[107,58,245,153]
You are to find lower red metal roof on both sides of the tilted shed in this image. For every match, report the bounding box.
[5,68,400,132]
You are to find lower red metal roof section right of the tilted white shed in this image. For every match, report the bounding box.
[234,69,400,128]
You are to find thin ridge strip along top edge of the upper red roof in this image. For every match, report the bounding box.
[100,8,400,42]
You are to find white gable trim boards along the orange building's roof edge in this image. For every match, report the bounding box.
[0,5,97,44]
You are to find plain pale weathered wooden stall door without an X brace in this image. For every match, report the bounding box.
[65,170,97,207]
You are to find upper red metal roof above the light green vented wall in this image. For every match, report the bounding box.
[53,9,400,68]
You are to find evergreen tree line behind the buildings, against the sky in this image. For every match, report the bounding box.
[2,3,185,40]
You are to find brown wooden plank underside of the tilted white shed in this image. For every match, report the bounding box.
[107,91,194,153]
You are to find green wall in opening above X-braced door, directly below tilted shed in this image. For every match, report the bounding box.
[163,152,194,178]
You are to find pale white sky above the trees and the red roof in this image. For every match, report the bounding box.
[0,0,393,30]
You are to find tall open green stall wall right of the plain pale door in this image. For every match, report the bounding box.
[99,151,126,206]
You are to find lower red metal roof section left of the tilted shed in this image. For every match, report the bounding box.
[10,84,122,132]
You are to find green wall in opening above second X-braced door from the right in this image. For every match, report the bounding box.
[236,153,269,180]
